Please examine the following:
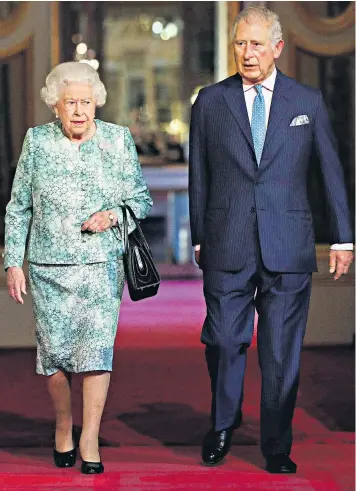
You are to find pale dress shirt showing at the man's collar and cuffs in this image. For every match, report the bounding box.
[195,68,354,251]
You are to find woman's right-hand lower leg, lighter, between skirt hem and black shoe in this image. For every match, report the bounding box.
[79,372,110,462]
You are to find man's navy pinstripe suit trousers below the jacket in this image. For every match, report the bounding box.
[201,221,311,457]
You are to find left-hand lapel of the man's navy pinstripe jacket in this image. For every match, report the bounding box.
[224,75,254,150]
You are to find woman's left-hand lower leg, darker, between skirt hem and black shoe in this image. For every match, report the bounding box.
[47,370,73,452]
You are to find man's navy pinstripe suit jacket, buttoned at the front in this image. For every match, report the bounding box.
[189,71,352,273]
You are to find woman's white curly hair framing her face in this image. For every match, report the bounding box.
[40,61,106,111]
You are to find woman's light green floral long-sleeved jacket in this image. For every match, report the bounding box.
[4,120,152,269]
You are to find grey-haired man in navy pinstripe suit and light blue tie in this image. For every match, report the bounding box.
[189,6,353,473]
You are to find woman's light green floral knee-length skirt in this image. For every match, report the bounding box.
[29,260,125,375]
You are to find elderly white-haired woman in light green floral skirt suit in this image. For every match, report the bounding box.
[4,62,152,474]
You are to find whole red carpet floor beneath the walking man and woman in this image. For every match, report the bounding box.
[0,281,355,491]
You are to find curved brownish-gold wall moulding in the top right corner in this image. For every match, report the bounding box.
[293,2,355,36]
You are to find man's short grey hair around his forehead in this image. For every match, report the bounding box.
[231,5,283,46]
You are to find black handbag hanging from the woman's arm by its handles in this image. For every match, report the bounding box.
[117,205,161,302]
